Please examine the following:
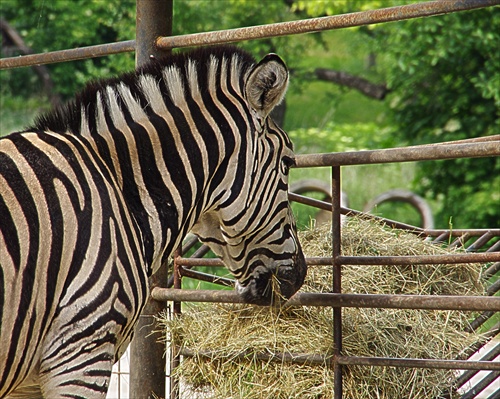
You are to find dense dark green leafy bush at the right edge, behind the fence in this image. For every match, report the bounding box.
[380,8,500,228]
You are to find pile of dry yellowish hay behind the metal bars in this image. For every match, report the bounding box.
[161,219,484,399]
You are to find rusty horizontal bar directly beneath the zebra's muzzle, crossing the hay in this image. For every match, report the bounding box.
[151,287,500,311]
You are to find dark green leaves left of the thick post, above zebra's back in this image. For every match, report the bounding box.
[0,0,135,97]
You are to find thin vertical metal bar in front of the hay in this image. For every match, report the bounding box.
[332,166,342,399]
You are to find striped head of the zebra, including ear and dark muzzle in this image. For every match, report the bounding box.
[193,50,307,305]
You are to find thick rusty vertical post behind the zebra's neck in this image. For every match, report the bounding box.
[129,0,173,399]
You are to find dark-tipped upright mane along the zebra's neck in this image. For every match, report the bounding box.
[30,46,255,134]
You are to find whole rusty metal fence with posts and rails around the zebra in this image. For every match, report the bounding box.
[0,0,500,399]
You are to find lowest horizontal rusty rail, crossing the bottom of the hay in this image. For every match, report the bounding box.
[180,348,500,371]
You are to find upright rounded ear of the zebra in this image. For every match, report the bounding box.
[245,54,288,118]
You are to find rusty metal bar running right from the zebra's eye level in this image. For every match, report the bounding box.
[295,141,500,168]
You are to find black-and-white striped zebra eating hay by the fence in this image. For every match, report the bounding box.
[0,46,307,399]
